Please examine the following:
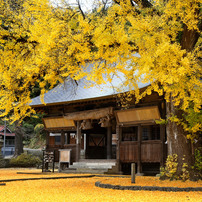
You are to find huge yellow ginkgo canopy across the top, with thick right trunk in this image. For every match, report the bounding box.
[0,0,202,177]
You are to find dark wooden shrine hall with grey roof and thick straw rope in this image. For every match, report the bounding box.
[31,69,167,173]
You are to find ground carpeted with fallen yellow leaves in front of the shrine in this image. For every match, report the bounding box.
[0,169,202,202]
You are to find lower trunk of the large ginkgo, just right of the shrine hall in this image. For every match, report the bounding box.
[166,98,194,175]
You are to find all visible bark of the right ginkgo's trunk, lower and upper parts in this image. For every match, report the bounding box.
[166,10,202,178]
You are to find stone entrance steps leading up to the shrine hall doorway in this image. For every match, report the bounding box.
[62,159,116,174]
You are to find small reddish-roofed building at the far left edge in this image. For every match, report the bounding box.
[0,125,15,156]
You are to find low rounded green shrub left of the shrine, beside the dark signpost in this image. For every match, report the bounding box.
[10,153,42,167]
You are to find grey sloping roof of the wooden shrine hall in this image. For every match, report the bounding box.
[30,64,149,106]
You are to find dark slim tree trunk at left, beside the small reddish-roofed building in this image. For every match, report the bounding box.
[14,122,24,157]
